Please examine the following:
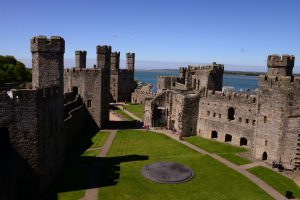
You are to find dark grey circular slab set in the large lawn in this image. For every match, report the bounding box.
[142,162,194,183]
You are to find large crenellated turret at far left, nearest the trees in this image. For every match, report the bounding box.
[31,36,65,89]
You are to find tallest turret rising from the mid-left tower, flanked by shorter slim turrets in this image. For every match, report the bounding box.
[96,45,111,70]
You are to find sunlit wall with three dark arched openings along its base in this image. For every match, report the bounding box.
[197,91,257,149]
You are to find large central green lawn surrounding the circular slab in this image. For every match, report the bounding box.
[98,130,272,200]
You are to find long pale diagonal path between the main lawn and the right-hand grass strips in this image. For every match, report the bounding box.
[152,130,286,200]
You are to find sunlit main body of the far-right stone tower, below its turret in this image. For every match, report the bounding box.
[254,75,300,167]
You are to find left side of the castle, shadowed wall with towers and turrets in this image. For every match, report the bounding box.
[0,36,135,200]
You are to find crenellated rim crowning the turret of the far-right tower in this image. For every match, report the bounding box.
[267,54,295,67]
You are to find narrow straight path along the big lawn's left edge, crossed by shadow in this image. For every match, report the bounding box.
[83,130,117,200]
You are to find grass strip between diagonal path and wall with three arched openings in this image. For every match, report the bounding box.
[185,136,251,165]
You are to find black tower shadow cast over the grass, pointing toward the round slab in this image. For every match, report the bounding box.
[43,155,149,200]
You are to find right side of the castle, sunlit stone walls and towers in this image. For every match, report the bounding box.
[144,55,300,169]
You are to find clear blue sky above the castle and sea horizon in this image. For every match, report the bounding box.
[0,0,300,72]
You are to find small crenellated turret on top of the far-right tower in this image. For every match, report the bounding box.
[267,54,295,76]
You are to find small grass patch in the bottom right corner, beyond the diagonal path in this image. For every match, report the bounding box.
[248,166,300,198]
